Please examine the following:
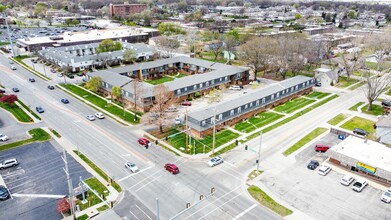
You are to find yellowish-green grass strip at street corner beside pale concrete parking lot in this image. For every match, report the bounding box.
[247,186,293,217]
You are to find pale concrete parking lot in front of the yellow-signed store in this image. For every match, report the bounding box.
[261,134,391,219]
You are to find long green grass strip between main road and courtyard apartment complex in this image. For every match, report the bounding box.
[61,84,140,124]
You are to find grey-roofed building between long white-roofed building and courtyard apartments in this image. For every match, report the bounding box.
[38,42,155,72]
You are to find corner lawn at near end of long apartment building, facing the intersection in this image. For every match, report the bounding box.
[168,130,239,154]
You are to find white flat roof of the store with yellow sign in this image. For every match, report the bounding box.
[329,136,391,172]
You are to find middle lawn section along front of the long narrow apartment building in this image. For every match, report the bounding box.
[235,112,283,133]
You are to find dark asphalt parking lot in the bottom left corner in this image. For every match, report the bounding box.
[0,142,91,219]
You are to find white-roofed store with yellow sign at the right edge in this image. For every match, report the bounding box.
[327,135,391,184]
